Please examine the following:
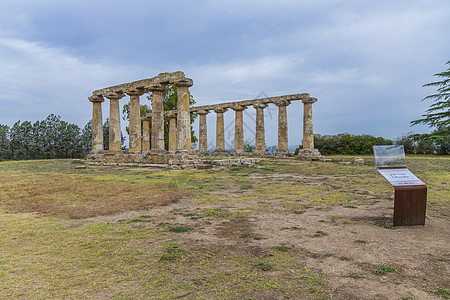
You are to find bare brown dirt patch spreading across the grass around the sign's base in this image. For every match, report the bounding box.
[81,176,450,299]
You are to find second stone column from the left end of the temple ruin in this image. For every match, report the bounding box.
[105,92,125,153]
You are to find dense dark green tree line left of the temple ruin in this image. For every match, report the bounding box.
[0,114,118,160]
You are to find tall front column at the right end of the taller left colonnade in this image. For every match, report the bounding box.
[174,78,193,151]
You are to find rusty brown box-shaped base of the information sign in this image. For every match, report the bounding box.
[394,184,427,226]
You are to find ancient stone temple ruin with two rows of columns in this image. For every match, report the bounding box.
[88,71,322,163]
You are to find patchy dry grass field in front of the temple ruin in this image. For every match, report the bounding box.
[0,156,450,299]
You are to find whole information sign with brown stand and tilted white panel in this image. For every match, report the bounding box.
[373,145,427,226]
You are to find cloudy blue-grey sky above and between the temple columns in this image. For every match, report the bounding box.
[0,0,450,147]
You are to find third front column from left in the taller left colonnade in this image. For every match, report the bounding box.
[126,89,145,153]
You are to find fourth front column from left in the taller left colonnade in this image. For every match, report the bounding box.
[149,84,166,153]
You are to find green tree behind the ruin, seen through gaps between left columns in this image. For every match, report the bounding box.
[122,78,198,150]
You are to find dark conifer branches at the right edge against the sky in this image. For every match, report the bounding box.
[411,60,450,128]
